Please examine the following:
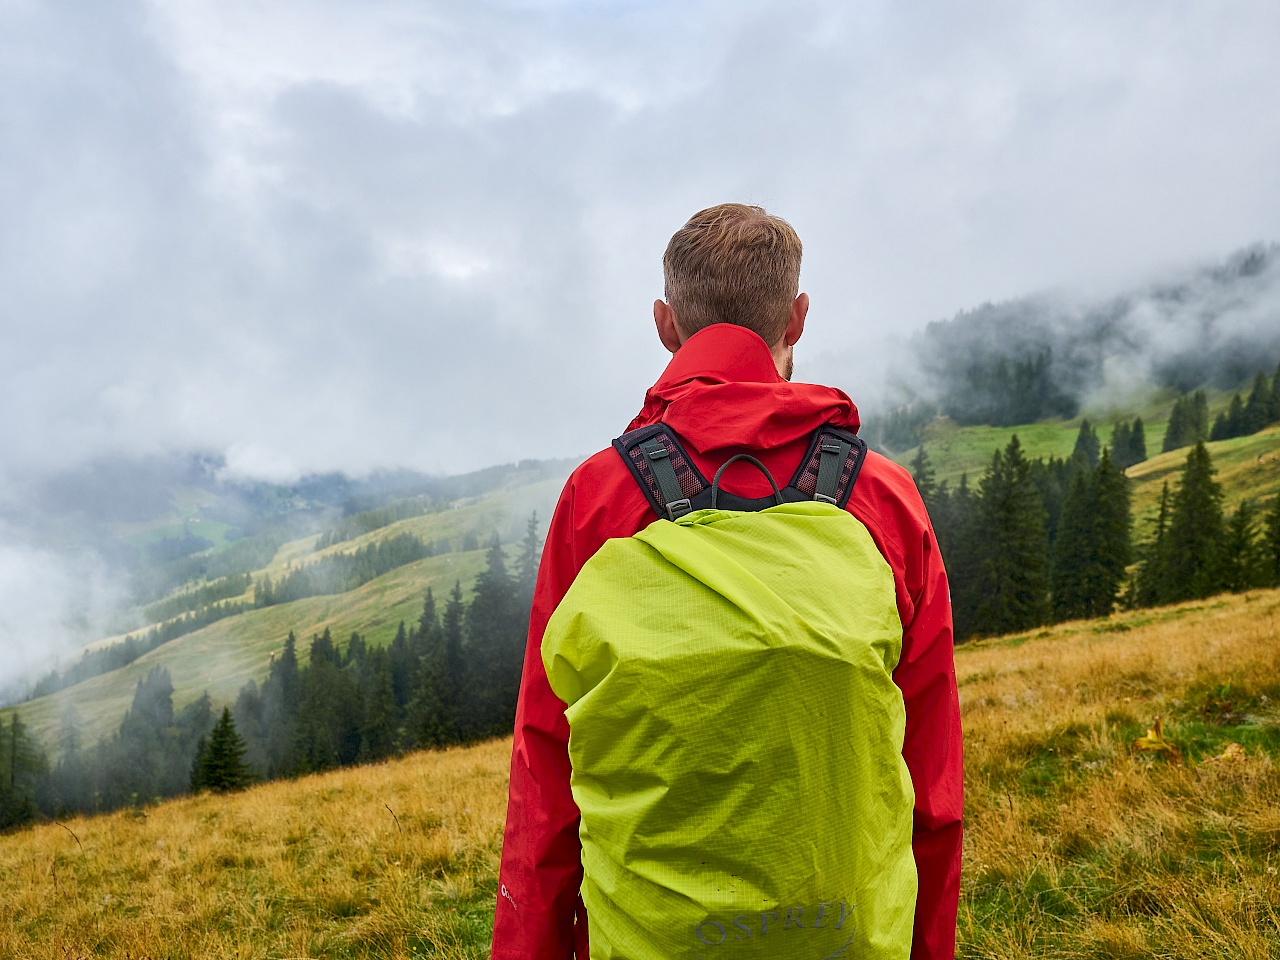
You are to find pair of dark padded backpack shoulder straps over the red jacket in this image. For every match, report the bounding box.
[613,422,867,520]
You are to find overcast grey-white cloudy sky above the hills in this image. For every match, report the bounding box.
[0,0,1280,480]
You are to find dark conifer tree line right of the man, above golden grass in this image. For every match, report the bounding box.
[911,421,1280,640]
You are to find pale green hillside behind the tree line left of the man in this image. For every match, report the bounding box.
[0,477,562,745]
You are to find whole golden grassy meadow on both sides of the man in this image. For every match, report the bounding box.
[0,590,1280,960]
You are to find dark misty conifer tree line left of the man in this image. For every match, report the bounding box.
[0,518,540,829]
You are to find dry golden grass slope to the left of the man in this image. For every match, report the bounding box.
[0,741,511,960]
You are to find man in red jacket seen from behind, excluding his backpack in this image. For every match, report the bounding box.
[493,204,963,960]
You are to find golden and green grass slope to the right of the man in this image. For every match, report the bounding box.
[956,591,1280,960]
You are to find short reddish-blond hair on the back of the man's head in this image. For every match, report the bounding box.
[662,204,803,347]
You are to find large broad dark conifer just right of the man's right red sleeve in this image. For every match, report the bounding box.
[977,434,1048,634]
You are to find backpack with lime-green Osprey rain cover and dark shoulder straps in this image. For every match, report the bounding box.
[541,424,916,960]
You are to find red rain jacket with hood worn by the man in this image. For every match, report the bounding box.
[493,324,964,960]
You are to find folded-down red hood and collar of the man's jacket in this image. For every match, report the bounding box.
[627,324,861,453]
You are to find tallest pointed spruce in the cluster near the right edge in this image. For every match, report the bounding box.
[1165,442,1222,602]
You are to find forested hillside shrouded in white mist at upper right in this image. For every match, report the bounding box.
[864,244,1280,452]
